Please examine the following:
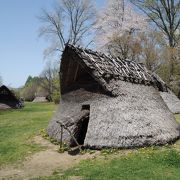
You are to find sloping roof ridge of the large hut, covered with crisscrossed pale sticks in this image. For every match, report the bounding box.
[62,43,167,95]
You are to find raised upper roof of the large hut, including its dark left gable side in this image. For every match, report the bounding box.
[60,44,166,96]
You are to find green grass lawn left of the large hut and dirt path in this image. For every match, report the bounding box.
[0,103,55,166]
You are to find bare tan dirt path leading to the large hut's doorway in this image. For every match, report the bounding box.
[0,136,98,180]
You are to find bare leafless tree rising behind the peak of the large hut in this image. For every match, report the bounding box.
[39,0,95,55]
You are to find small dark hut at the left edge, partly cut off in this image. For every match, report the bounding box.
[0,85,23,109]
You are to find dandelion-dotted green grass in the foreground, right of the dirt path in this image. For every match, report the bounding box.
[36,114,180,180]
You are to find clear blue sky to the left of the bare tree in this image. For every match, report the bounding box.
[0,0,104,87]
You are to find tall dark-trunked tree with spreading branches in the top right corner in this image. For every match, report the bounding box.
[131,0,180,47]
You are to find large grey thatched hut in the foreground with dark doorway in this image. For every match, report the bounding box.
[47,44,180,149]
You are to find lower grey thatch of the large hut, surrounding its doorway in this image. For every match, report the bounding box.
[47,81,180,149]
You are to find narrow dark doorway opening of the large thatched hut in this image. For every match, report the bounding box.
[70,105,90,147]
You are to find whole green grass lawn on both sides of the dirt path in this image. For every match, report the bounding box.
[0,103,180,180]
